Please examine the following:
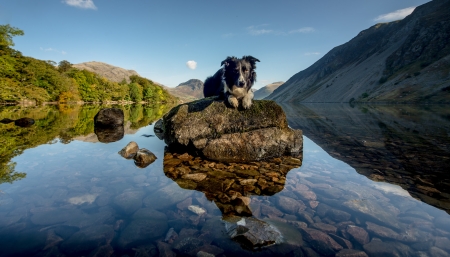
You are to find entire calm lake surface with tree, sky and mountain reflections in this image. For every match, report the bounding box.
[0,104,450,256]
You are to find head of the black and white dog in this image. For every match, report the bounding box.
[220,56,259,91]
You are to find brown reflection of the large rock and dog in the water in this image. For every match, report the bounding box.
[164,148,302,249]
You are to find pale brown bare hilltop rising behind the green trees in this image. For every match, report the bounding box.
[72,62,139,83]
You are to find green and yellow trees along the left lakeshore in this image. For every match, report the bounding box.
[0,24,177,104]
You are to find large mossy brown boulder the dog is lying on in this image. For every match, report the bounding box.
[158,97,303,162]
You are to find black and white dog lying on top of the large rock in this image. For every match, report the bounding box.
[203,56,259,109]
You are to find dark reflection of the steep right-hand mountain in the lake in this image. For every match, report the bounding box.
[282,104,450,213]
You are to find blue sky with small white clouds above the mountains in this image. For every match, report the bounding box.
[0,0,428,89]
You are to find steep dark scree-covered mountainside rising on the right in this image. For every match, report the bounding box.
[267,0,450,103]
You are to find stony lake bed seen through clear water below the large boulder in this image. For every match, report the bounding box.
[0,103,450,257]
